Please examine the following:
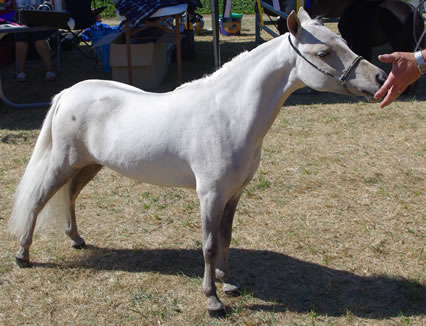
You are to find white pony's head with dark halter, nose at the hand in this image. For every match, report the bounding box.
[286,8,386,101]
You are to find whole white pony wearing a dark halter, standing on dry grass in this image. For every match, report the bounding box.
[9,8,386,315]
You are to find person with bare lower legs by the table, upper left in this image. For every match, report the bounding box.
[14,0,56,82]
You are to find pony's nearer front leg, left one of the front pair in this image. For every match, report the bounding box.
[199,192,225,316]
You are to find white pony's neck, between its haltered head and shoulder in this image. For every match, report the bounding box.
[212,35,304,140]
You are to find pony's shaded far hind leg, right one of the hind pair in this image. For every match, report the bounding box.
[65,164,103,249]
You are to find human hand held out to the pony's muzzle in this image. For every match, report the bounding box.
[374,52,421,108]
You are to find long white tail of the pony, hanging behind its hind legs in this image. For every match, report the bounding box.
[9,91,70,238]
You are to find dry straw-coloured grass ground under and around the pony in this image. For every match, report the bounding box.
[0,14,426,325]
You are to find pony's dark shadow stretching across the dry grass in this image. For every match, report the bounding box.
[34,246,426,319]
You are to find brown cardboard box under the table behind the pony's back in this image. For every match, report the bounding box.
[110,38,168,91]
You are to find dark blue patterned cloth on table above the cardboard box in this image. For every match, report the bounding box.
[115,0,202,27]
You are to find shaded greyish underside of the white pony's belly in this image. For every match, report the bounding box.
[106,163,196,189]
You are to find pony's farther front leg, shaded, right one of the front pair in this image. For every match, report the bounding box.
[216,193,241,296]
